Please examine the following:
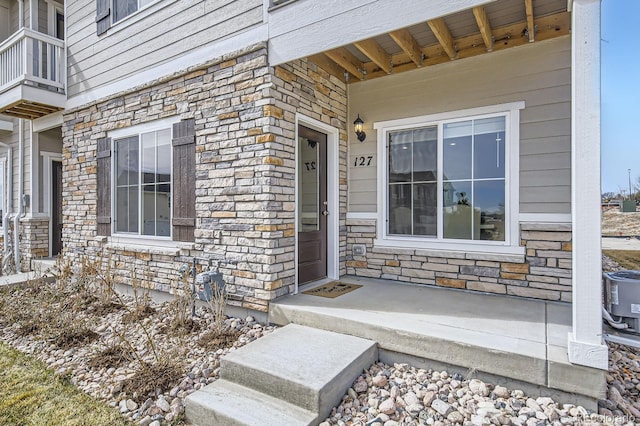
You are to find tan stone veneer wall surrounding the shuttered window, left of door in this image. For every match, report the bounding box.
[62,45,346,312]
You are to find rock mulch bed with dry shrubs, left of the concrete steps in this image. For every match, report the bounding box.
[0,280,275,426]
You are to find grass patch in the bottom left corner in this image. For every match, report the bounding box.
[0,343,131,426]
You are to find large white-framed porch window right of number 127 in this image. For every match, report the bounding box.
[375,103,524,248]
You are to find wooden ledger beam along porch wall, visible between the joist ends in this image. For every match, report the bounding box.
[365,12,571,80]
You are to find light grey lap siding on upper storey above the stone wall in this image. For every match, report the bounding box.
[67,0,263,97]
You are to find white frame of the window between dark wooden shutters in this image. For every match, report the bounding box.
[108,117,180,244]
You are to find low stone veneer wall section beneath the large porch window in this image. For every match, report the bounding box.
[347,219,571,302]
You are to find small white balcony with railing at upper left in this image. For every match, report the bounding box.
[0,28,67,120]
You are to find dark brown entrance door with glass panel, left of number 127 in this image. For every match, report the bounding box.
[298,126,329,284]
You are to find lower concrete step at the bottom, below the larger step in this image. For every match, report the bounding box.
[186,379,318,426]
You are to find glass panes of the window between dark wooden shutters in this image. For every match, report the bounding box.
[114,129,171,237]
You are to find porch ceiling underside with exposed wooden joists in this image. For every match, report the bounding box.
[309,0,571,83]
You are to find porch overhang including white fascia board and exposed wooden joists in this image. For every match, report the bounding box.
[269,0,571,83]
